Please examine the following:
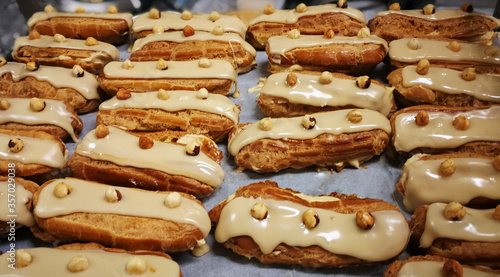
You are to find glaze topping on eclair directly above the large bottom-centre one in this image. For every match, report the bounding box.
[228,109,391,156]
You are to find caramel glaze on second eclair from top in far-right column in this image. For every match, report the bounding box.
[389,38,500,64]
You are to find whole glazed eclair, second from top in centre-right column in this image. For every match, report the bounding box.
[266,28,388,76]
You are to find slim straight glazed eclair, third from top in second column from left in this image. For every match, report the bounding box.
[100,59,238,96]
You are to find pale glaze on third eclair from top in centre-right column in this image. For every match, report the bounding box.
[260,72,392,116]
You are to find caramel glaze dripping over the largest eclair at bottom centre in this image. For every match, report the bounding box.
[215,197,410,261]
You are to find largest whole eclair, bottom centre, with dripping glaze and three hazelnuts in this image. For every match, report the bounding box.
[209,181,410,267]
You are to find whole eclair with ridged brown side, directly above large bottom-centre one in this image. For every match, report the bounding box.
[228,109,391,172]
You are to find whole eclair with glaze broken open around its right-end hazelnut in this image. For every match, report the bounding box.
[68,125,224,198]
